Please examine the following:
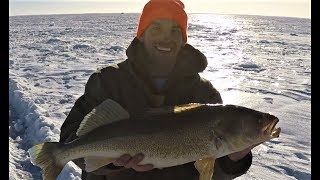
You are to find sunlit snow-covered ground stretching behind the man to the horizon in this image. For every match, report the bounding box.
[9,14,311,180]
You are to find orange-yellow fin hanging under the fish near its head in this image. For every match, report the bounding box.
[194,158,215,180]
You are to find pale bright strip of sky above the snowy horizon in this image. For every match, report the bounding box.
[9,0,311,18]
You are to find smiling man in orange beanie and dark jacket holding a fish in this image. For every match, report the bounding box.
[60,0,252,180]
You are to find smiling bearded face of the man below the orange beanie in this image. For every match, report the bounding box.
[140,19,184,65]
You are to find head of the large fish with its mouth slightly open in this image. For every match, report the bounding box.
[213,105,281,150]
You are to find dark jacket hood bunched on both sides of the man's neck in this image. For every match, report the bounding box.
[126,38,208,77]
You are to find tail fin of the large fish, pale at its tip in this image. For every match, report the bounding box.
[28,142,64,180]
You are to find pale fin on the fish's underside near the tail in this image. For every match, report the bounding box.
[84,156,114,172]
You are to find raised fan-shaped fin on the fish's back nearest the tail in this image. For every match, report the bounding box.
[76,99,130,137]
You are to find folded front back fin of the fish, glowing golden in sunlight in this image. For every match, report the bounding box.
[147,103,204,115]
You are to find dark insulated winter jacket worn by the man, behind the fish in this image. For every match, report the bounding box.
[60,38,252,180]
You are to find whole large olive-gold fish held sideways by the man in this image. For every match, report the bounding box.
[28,99,280,180]
